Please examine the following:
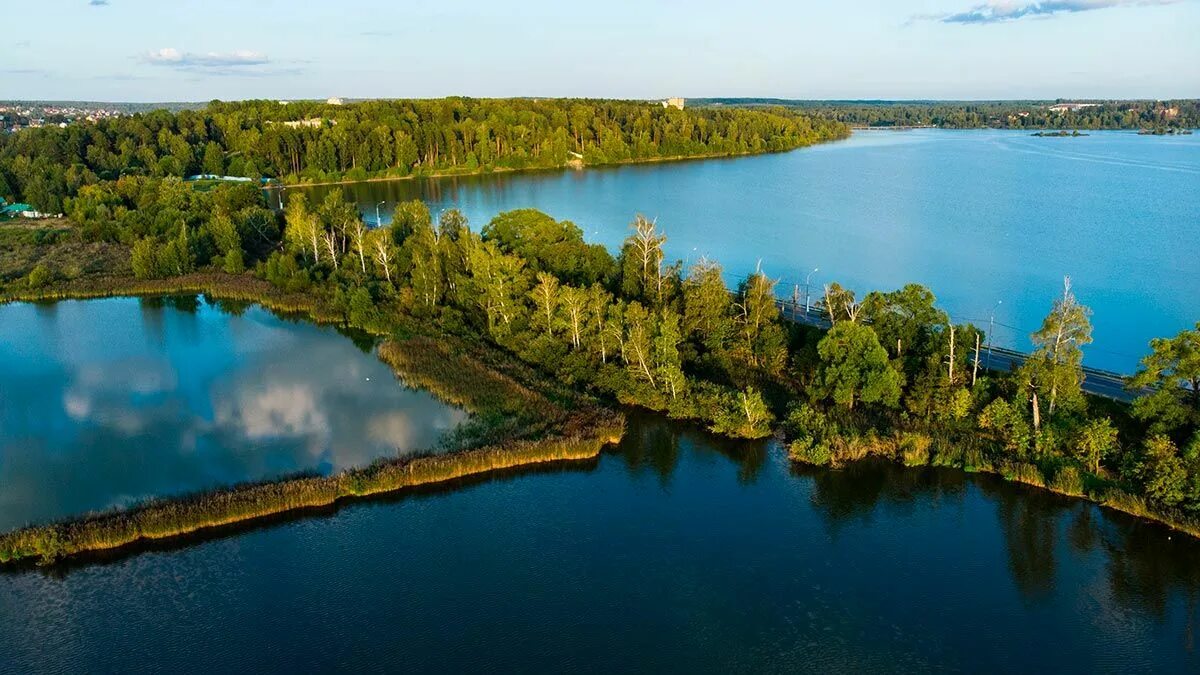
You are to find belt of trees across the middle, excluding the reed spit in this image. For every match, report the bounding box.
[8,177,1200,531]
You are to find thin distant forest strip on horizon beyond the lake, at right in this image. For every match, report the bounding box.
[702,98,1200,130]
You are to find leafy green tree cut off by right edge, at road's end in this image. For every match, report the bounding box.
[1129,322,1200,434]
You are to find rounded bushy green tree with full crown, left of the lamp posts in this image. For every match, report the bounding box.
[817,321,900,410]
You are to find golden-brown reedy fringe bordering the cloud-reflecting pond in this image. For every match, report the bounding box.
[0,273,624,565]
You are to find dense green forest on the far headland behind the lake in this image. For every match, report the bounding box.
[0,98,848,213]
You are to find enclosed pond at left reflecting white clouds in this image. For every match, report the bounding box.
[0,297,466,528]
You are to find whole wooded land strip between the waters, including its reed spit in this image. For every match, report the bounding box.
[0,100,1200,561]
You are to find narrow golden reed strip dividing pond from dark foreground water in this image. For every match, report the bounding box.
[0,410,624,563]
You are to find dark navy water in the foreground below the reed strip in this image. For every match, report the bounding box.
[0,418,1200,673]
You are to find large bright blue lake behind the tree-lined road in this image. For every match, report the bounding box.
[302,130,1200,371]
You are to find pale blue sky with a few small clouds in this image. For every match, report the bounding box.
[0,0,1200,101]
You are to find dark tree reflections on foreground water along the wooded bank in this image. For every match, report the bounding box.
[619,414,1200,629]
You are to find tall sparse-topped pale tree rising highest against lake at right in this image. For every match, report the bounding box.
[1019,277,1092,426]
